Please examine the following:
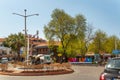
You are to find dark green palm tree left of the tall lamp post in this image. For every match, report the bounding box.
[3,33,25,59]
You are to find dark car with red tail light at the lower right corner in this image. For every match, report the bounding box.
[99,57,120,80]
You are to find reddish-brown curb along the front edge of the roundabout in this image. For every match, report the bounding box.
[0,69,74,76]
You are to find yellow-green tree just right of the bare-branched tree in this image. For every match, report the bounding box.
[89,30,107,53]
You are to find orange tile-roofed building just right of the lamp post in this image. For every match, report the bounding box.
[29,37,49,55]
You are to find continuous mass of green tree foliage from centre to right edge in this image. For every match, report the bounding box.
[44,9,120,57]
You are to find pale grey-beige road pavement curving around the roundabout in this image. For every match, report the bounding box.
[0,65,104,80]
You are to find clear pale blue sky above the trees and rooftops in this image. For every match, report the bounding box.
[0,0,120,39]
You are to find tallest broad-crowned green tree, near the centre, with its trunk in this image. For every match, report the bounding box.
[44,9,86,58]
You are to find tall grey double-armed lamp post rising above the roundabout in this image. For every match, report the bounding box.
[13,9,39,60]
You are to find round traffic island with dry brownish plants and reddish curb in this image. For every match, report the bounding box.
[0,62,74,76]
